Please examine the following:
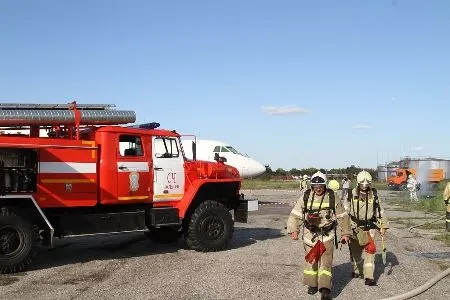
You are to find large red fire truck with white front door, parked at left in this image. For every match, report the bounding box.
[0,102,257,273]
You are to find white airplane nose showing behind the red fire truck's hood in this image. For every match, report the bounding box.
[183,140,266,178]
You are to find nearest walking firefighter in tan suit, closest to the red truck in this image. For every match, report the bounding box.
[287,172,351,299]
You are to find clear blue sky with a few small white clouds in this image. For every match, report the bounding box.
[0,0,450,170]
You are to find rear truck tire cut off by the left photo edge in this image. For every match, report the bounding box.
[0,207,39,274]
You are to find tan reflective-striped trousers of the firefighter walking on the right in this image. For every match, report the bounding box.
[348,235,375,279]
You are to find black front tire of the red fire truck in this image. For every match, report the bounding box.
[185,200,234,252]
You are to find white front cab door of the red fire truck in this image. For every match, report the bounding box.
[152,137,184,202]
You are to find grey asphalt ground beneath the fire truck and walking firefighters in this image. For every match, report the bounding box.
[0,190,450,300]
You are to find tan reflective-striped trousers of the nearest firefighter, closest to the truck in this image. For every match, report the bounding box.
[303,239,334,290]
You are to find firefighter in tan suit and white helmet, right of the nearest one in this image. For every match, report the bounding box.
[349,171,389,286]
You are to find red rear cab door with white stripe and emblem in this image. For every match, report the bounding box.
[117,134,150,202]
